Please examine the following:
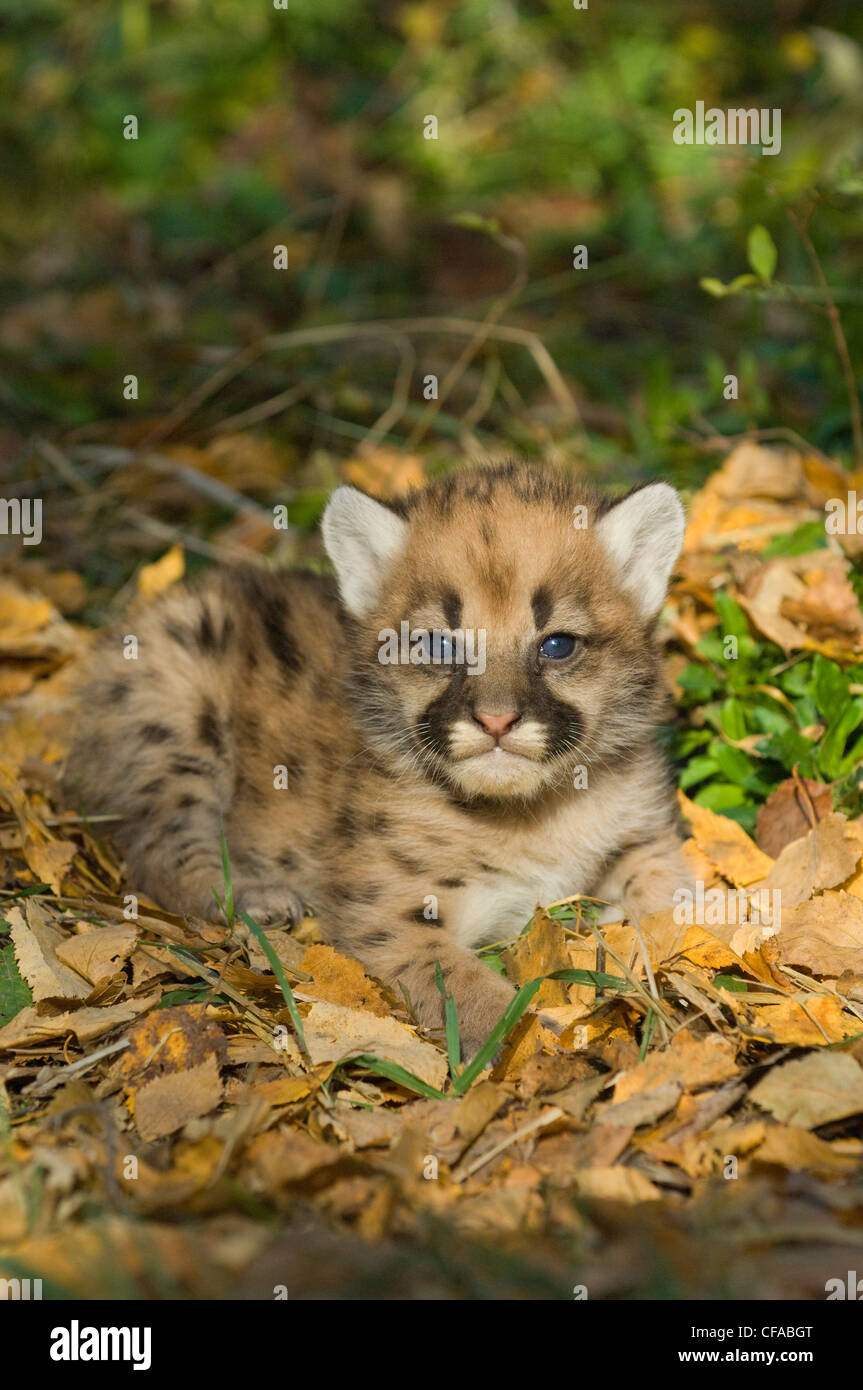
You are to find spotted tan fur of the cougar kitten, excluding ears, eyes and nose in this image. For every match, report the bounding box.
[67,467,687,1051]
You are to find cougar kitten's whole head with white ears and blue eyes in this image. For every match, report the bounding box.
[322,464,684,801]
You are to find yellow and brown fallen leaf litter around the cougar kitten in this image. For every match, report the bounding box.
[0,445,863,1297]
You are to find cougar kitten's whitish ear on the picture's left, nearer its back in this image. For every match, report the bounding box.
[321,488,407,617]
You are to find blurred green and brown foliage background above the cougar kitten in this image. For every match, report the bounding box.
[0,0,863,567]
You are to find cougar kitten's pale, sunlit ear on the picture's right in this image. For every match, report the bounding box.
[596,482,687,617]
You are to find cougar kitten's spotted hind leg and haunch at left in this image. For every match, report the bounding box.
[64,591,302,923]
